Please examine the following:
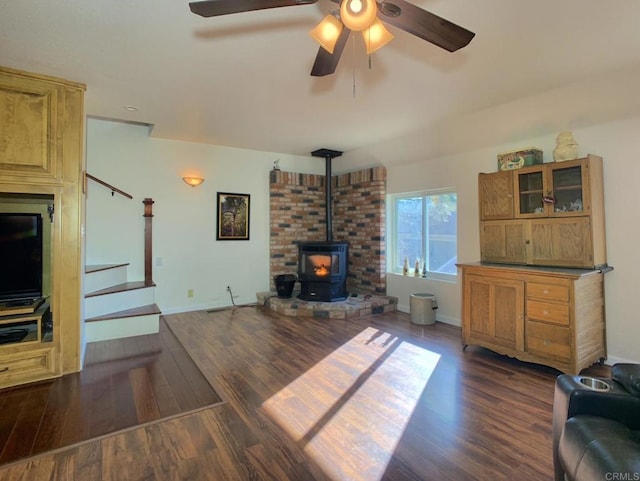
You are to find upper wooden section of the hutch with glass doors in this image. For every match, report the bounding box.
[478,155,607,268]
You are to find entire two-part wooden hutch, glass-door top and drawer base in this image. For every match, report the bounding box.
[459,155,611,373]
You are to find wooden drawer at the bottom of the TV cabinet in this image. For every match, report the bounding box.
[0,348,55,387]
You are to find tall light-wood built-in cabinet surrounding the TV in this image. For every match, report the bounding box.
[0,67,85,387]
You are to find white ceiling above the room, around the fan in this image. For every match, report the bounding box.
[0,0,640,155]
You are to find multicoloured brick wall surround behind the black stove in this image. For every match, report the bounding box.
[270,167,386,294]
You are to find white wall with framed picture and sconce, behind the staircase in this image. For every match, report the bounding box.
[86,119,324,313]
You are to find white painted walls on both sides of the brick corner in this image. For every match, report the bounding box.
[87,63,640,362]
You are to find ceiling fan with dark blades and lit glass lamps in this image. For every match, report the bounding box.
[189,0,475,77]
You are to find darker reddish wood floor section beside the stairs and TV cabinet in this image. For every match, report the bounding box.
[0,320,221,464]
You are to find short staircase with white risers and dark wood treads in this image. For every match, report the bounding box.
[84,263,161,342]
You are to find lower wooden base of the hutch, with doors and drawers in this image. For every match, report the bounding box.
[458,263,606,374]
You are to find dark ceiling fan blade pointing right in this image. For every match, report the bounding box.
[378,0,476,52]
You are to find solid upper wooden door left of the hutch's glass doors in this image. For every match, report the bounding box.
[478,171,514,220]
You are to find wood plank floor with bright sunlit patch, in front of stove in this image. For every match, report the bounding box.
[0,307,606,481]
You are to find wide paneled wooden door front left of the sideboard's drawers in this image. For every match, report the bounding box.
[462,274,524,352]
